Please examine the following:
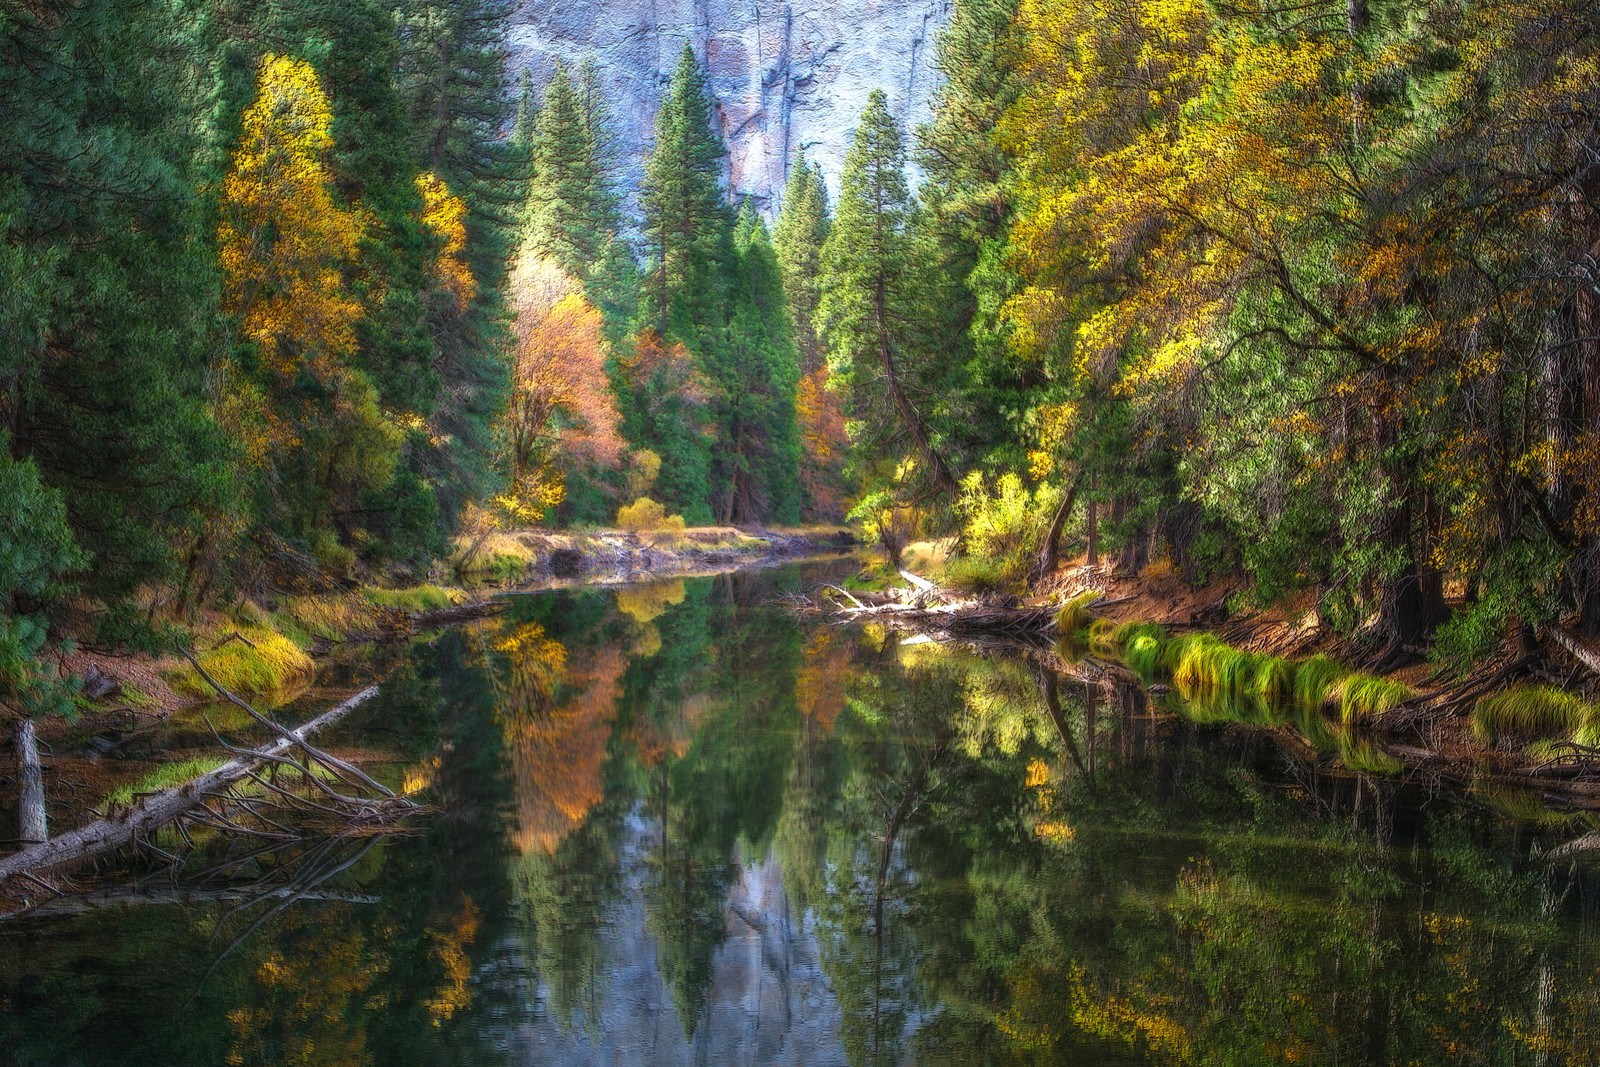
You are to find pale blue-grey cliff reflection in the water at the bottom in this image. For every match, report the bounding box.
[486,809,845,1067]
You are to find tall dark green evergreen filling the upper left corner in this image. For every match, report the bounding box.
[0,0,235,637]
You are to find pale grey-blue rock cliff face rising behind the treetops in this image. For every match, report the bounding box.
[510,0,954,211]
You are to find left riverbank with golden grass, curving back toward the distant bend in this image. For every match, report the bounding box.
[0,526,856,851]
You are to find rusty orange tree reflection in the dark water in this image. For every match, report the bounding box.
[506,648,627,854]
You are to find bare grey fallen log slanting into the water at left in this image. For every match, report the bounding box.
[0,686,378,885]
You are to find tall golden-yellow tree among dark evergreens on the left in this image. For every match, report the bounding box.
[216,54,400,544]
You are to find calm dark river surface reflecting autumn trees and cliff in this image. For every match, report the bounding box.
[0,565,1600,1067]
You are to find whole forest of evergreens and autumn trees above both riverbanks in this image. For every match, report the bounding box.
[0,0,1600,726]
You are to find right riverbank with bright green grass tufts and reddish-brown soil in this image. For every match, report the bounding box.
[844,545,1600,809]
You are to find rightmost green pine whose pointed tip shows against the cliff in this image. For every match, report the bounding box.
[819,90,958,502]
